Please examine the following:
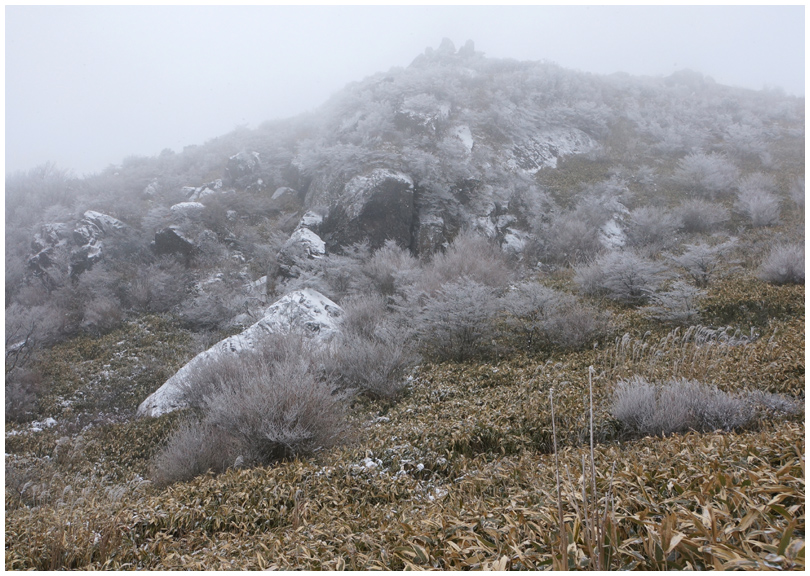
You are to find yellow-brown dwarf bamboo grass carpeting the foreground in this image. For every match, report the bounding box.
[5,284,805,569]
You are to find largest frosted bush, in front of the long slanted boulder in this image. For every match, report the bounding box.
[160,335,348,482]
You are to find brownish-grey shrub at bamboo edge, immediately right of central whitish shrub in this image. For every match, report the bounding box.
[501,282,608,349]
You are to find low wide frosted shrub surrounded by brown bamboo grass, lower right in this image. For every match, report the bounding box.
[610,376,757,436]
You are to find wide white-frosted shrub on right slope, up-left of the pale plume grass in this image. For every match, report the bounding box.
[574,250,666,304]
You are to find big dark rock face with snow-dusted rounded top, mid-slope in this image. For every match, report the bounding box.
[319,169,414,251]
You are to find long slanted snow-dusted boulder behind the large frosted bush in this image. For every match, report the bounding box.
[138,289,343,417]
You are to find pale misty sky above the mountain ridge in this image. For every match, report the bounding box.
[5,6,805,175]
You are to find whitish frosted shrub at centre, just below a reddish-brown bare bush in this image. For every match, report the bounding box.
[412,277,498,361]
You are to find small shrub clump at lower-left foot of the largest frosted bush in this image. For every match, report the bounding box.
[150,419,241,487]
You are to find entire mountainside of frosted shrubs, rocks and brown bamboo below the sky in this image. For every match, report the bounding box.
[5,40,805,569]
